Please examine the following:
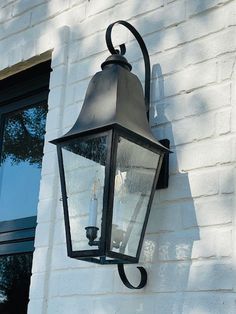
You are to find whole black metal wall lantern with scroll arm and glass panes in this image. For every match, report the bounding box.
[52,21,169,289]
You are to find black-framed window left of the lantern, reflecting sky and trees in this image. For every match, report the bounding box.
[0,61,50,314]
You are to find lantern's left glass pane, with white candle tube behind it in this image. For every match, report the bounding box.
[62,136,107,251]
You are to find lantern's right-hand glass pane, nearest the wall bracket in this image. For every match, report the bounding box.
[111,138,159,257]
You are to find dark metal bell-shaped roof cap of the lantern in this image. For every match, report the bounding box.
[52,55,168,151]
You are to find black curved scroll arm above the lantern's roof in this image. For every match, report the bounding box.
[106,20,151,116]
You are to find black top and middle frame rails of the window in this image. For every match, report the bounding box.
[0,60,51,256]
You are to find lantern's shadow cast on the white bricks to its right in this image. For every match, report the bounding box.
[141,64,200,313]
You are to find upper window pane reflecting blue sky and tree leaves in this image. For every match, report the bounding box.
[0,105,47,221]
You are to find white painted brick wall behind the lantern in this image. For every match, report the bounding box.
[0,0,236,314]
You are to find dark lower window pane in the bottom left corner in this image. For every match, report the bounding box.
[0,253,32,314]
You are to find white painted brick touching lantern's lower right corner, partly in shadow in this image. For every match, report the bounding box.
[141,229,232,264]
